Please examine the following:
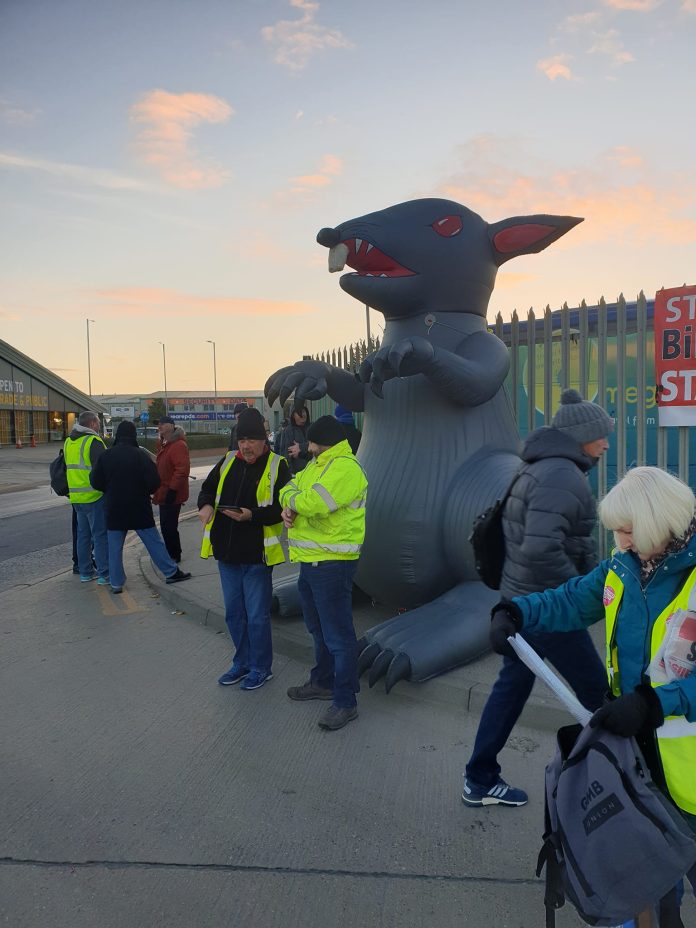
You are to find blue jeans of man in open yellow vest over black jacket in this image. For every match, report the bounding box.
[218,561,273,674]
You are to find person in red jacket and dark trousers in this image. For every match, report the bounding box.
[152,416,191,564]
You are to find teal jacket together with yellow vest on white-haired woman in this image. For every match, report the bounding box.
[513,537,696,814]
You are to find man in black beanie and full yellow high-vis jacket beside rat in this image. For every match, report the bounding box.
[280,416,367,731]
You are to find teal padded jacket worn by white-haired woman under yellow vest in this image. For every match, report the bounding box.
[513,536,696,722]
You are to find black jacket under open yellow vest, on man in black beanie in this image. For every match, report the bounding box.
[198,451,290,564]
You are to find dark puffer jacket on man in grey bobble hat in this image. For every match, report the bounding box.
[500,428,597,596]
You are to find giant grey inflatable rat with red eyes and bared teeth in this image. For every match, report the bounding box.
[265,199,582,692]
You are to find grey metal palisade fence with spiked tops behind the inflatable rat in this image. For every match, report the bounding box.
[312,291,696,556]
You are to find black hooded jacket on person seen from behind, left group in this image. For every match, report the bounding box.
[89,439,160,531]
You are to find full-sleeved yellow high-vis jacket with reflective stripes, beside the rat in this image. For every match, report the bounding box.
[280,441,367,563]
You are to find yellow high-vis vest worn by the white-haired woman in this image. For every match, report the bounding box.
[603,568,696,815]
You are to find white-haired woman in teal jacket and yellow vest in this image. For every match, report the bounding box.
[491,467,696,928]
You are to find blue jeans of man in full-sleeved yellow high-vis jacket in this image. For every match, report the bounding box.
[297,561,360,709]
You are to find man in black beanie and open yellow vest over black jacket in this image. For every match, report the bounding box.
[198,408,290,690]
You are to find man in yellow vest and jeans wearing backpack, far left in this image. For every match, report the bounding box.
[63,412,109,586]
